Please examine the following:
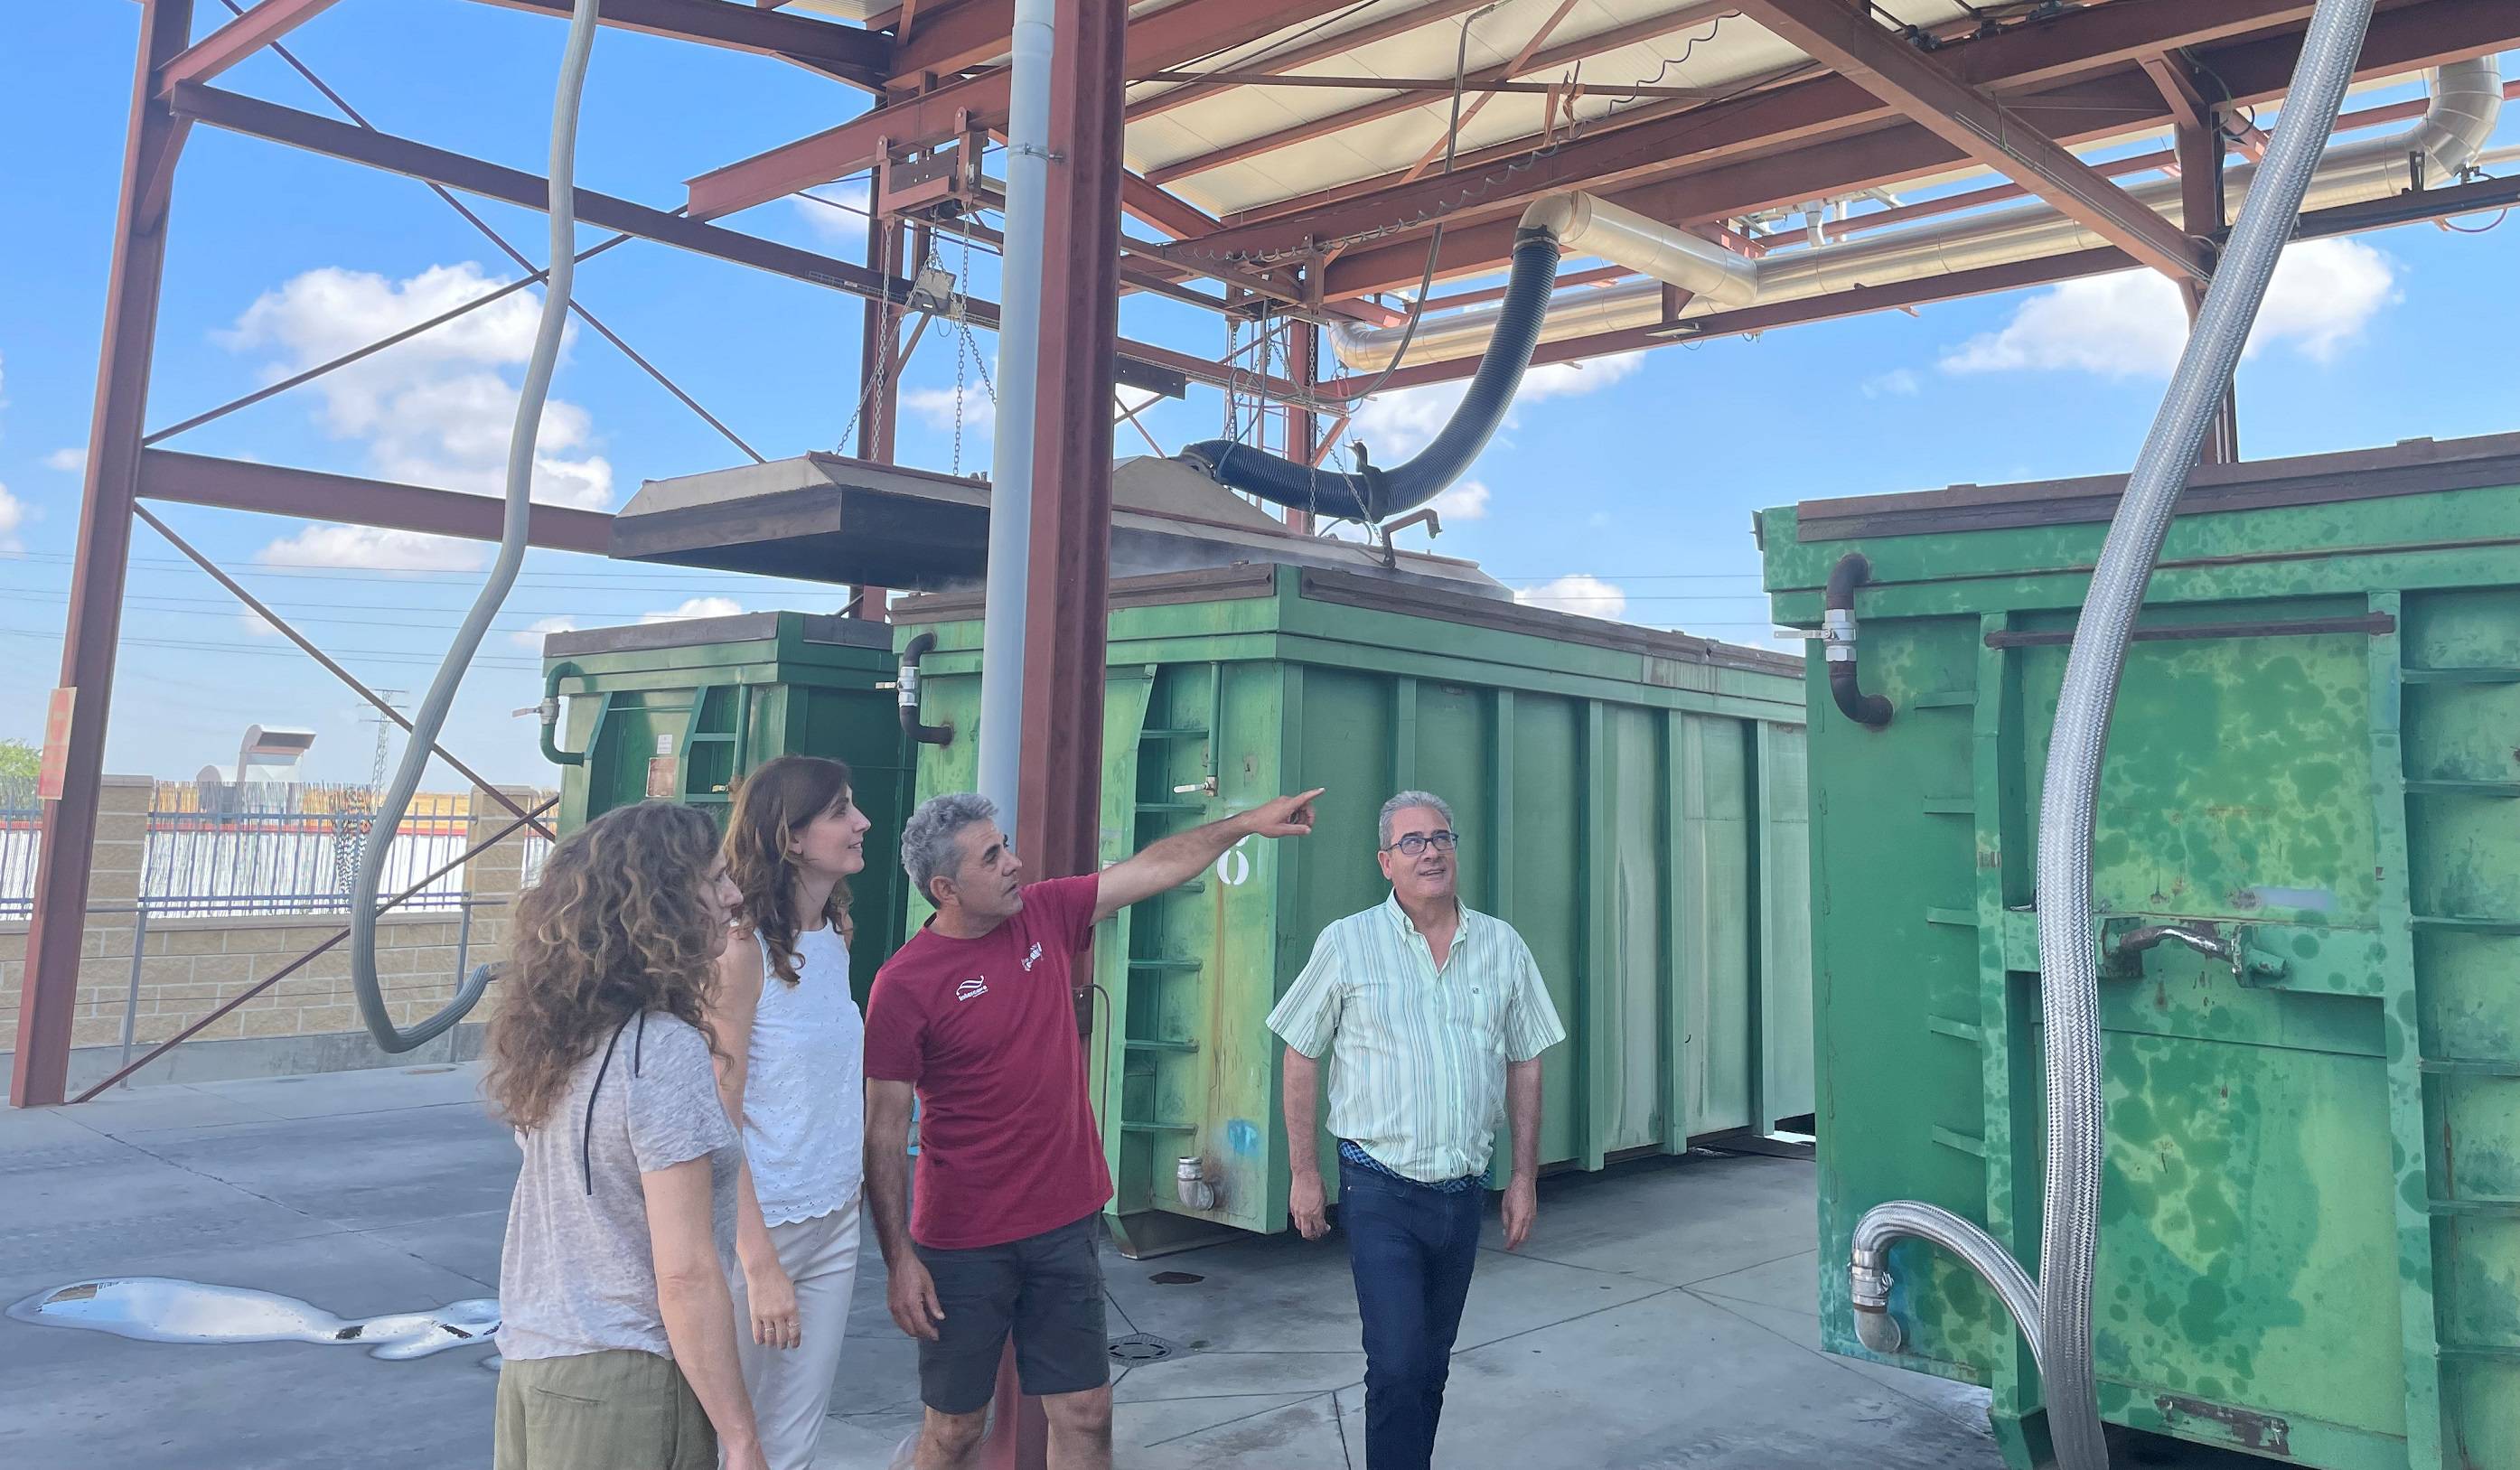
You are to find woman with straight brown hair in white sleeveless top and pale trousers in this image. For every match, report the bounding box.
[710,756,867,1470]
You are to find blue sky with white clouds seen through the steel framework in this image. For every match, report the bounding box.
[0,0,2520,787]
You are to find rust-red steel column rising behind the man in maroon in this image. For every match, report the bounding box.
[1016,0,1129,877]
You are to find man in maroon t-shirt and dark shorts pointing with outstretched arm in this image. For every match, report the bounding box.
[867,791,1320,1470]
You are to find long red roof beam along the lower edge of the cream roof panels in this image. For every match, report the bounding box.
[1169,0,2328,267]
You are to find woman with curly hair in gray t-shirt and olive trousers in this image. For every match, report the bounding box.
[483,801,763,1470]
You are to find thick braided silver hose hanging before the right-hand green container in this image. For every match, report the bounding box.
[1852,0,2374,1470]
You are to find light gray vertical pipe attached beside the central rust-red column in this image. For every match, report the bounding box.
[978,0,1043,821]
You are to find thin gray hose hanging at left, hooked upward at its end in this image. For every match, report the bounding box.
[351,0,603,1052]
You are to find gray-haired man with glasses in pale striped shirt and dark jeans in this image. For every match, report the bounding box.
[1268,791,1565,1470]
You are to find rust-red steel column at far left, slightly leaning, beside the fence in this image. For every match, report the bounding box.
[7,0,192,1107]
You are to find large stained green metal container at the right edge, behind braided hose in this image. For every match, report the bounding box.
[1759,436,2520,1470]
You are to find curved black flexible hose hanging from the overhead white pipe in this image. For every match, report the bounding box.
[1175,229,1558,522]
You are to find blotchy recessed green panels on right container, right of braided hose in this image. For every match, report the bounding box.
[2021,613,2406,1435]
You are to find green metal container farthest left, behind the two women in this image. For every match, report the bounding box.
[542,613,910,1001]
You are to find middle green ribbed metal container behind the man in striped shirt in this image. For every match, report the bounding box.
[895,567,1812,1253]
